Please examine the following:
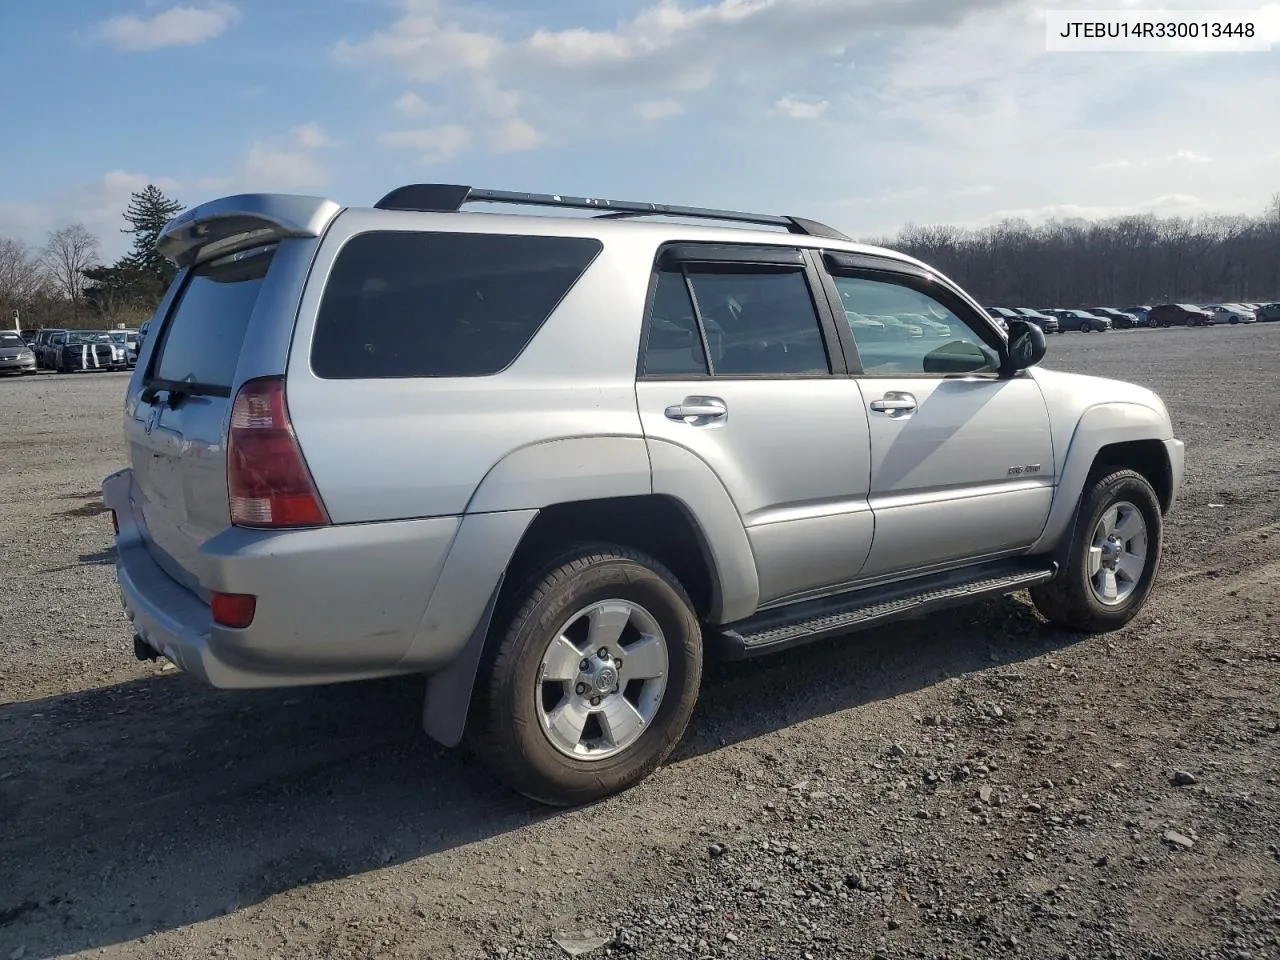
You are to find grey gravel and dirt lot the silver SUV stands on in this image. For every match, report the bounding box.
[0,324,1280,960]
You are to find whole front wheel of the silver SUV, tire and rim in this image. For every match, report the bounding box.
[1030,470,1162,634]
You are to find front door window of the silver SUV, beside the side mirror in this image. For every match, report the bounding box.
[835,276,1000,376]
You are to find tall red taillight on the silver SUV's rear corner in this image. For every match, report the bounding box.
[227,376,329,527]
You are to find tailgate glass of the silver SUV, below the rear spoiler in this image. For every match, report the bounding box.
[151,246,275,393]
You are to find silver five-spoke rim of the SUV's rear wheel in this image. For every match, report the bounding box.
[534,600,668,760]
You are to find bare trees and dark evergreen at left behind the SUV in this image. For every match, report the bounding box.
[0,184,183,329]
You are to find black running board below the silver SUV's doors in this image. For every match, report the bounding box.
[707,558,1057,660]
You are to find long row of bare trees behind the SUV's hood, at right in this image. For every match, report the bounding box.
[874,193,1280,308]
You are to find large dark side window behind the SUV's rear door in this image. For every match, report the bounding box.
[311,232,600,380]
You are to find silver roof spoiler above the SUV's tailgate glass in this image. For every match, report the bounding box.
[156,193,342,268]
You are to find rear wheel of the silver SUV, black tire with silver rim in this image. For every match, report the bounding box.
[467,544,703,806]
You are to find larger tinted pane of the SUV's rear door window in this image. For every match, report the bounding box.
[689,270,831,376]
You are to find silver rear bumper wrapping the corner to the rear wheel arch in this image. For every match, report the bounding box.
[102,470,527,687]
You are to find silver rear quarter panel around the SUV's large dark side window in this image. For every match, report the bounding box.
[288,210,654,524]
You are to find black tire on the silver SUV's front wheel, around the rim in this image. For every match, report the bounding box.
[1030,467,1164,634]
